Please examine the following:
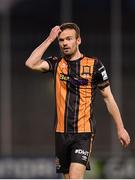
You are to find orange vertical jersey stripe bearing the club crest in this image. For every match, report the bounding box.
[78,58,94,132]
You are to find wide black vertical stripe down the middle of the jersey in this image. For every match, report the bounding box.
[65,60,80,132]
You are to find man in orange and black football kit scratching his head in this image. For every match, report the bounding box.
[26,23,130,179]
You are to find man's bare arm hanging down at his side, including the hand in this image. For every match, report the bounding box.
[100,86,130,147]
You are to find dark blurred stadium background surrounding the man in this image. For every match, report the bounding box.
[0,0,135,179]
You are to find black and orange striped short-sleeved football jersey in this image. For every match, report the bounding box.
[46,56,109,133]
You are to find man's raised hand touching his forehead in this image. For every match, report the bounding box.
[48,26,61,42]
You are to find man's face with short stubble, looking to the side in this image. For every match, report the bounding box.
[58,29,81,56]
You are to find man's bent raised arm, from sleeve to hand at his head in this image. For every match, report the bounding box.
[25,26,61,72]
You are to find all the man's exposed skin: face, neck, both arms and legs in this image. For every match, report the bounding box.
[25,26,130,179]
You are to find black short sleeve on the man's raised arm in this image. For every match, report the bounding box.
[45,56,58,72]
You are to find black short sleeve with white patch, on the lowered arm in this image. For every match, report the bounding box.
[95,59,110,90]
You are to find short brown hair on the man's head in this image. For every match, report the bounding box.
[60,22,80,38]
